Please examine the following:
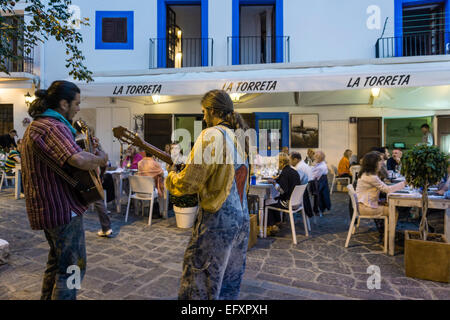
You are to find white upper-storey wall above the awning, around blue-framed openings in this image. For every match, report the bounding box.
[40,0,394,82]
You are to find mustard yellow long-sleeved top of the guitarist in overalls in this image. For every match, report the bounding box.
[166,126,245,212]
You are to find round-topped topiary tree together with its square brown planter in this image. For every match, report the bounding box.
[401,145,450,282]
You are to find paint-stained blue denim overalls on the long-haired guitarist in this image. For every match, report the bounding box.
[179,127,250,300]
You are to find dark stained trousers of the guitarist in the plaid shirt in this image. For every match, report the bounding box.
[41,216,86,300]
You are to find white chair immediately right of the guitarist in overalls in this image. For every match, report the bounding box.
[264,184,311,244]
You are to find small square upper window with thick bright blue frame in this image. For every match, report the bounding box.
[95,11,134,50]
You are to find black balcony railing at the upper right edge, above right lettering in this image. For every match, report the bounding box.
[375,32,450,58]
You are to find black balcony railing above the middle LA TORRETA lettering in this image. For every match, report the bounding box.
[227,36,291,65]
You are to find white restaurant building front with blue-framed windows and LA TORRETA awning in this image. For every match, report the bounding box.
[0,0,450,165]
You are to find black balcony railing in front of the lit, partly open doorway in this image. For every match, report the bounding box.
[149,38,214,69]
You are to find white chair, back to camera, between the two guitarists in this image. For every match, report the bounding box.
[125,176,158,226]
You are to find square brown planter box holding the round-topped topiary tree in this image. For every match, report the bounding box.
[405,231,450,283]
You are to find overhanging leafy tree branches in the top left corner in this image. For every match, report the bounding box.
[0,0,93,82]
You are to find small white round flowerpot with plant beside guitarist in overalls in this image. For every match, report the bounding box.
[170,194,198,229]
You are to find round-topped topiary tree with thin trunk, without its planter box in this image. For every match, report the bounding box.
[401,145,449,240]
